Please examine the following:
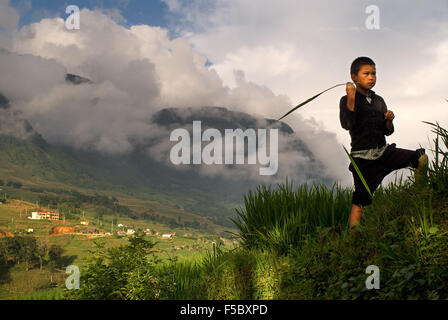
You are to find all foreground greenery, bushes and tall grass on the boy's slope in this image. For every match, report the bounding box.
[60,125,448,299]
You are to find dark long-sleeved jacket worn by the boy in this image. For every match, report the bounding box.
[339,90,394,151]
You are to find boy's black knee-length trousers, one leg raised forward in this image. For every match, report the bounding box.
[348,143,425,207]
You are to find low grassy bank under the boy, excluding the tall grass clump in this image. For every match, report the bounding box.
[161,179,448,300]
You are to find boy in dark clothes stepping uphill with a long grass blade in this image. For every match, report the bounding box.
[339,57,428,230]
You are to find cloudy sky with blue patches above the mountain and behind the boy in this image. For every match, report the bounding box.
[0,0,448,185]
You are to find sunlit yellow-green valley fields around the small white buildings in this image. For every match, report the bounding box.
[0,199,233,299]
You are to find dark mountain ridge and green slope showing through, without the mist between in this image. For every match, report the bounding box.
[0,74,331,225]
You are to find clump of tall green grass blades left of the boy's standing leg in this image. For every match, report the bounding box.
[234,181,351,254]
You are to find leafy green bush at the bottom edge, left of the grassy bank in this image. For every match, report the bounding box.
[66,231,174,300]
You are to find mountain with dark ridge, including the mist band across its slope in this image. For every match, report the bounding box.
[0,75,333,228]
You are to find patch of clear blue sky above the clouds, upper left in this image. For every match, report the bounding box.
[11,0,172,28]
